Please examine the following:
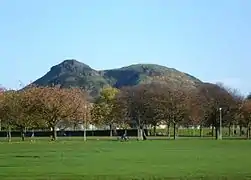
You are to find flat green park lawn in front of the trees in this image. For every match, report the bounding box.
[0,138,251,180]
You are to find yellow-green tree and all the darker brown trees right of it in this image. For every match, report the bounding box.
[92,82,251,139]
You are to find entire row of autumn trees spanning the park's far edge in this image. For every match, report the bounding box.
[0,82,251,140]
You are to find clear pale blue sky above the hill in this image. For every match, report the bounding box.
[0,0,251,94]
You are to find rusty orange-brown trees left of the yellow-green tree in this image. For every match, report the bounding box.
[0,87,89,140]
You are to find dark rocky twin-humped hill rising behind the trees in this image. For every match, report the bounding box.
[33,59,202,97]
